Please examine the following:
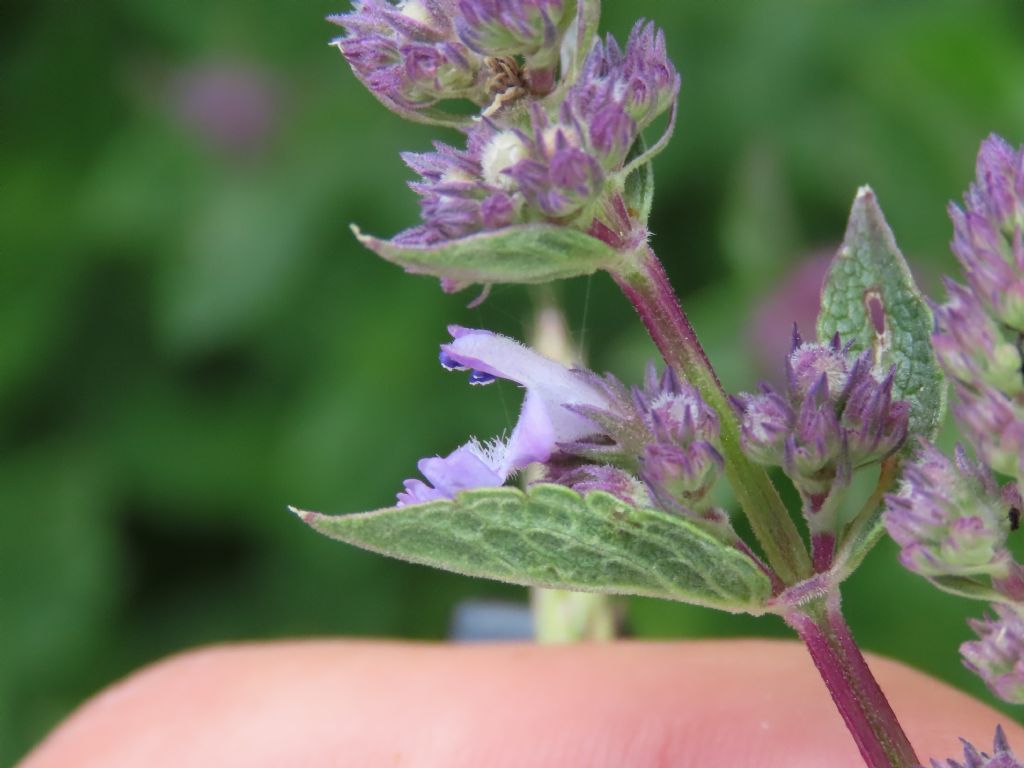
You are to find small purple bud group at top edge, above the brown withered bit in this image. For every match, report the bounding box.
[456,0,570,67]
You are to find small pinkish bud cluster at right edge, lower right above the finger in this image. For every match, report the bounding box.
[961,605,1024,708]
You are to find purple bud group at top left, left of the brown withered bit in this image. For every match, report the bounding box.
[328,0,487,117]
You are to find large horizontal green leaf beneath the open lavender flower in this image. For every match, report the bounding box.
[293,484,771,613]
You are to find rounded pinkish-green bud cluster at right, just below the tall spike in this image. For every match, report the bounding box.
[883,443,1020,579]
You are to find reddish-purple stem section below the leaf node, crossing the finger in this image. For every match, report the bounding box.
[785,590,921,768]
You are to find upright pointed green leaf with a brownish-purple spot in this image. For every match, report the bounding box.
[818,186,946,451]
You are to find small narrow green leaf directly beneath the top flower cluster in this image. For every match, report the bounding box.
[352,224,620,285]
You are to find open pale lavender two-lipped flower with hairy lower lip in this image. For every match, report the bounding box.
[398,326,610,504]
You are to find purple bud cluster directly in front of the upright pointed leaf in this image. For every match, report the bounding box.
[734,331,909,498]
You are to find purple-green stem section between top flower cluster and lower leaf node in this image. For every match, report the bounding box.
[612,244,812,585]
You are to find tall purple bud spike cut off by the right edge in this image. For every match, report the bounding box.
[933,136,1024,478]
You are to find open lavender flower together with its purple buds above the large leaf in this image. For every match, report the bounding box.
[398,327,724,522]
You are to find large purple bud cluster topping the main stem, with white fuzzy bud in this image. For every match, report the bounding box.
[331,0,680,268]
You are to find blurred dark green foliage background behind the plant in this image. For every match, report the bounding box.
[8,0,1024,764]
